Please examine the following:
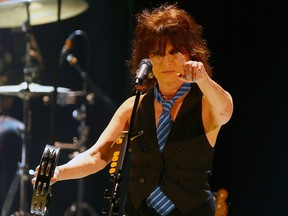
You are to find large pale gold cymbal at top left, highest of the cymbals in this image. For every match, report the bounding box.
[0,0,89,28]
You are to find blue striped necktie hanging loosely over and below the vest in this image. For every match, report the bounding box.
[146,83,191,216]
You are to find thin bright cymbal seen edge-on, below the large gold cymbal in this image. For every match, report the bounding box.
[0,82,70,99]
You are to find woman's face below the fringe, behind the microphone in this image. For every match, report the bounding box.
[149,40,189,83]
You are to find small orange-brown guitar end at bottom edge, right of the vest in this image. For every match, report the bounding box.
[214,188,228,216]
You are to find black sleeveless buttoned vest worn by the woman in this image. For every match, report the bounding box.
[128,85,213,213]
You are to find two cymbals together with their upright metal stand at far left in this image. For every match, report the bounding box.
[0,0,84,216]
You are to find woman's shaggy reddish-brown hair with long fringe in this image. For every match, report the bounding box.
[127,3,212,91]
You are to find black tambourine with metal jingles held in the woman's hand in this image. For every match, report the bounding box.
[30,145,60,215]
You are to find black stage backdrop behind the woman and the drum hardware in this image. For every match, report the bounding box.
[0,0,288,216]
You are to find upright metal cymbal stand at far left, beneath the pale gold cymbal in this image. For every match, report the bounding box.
[1,1,35,216]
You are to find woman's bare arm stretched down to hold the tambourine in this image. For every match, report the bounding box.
[32,97,134,183]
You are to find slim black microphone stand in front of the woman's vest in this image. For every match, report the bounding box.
[102,88,142,216]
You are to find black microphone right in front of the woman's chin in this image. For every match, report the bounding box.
[134,59,152,86]
